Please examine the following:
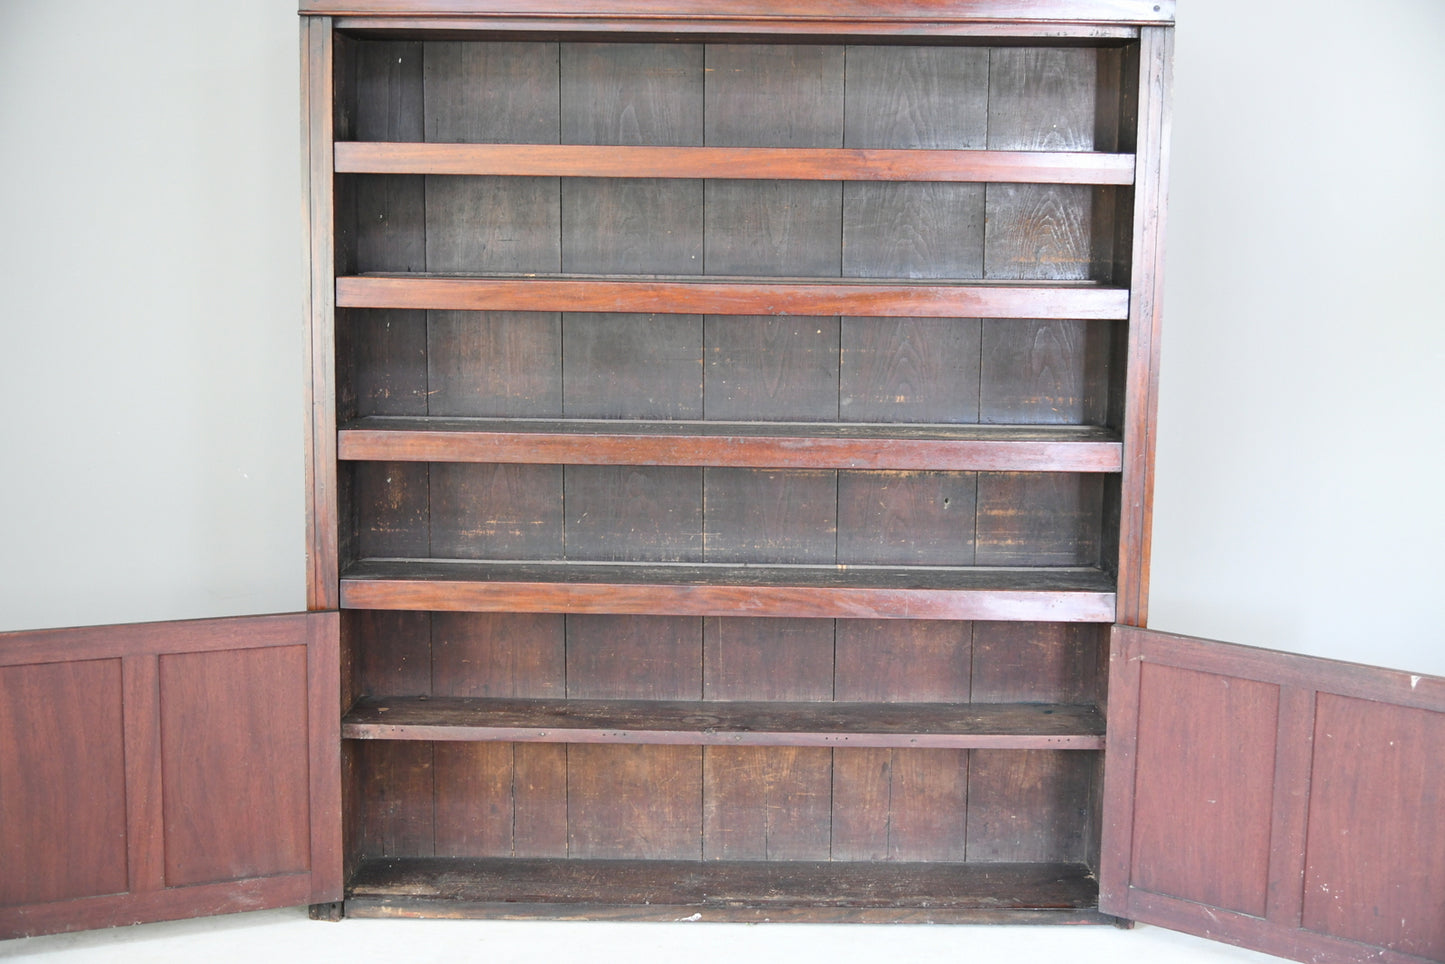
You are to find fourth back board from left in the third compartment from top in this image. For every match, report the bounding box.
[702,315,840,422]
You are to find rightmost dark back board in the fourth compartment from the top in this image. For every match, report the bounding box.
[974,473,1104,565]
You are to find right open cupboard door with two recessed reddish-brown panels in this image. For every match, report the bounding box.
[1100,626,1445,964]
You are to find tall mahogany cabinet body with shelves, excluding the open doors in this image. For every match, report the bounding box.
[308,3,1169,921]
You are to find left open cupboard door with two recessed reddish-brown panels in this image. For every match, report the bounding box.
[0,613,341,938]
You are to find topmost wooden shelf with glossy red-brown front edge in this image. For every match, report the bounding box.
[335,142,1134,185]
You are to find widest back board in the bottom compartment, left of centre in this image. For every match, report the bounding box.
[566,743,702,860]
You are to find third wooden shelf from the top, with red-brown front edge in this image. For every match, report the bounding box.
[338,416,1123,473]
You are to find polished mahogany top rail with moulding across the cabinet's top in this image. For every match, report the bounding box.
[299,0,1175,42]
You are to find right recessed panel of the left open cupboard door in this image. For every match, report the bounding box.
[159,640,311,887]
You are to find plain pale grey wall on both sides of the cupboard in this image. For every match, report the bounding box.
[0,0,1445,673]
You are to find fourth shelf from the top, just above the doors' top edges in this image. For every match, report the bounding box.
[341,559,1114,623]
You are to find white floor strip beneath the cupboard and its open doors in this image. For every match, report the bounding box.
[0,908,1280,964]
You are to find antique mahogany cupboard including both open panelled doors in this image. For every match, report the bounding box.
[0,0,1445,963]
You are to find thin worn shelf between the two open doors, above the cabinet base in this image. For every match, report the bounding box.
[341,697,1104,750]
